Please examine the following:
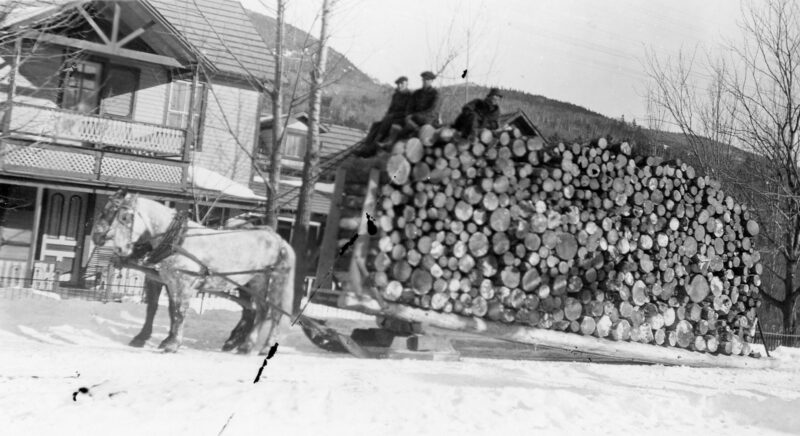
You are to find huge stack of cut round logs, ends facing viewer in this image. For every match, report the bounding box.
[352,126,762,355]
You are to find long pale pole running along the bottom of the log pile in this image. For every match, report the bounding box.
[339,299,778,369]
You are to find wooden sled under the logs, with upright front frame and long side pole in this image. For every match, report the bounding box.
[304,158,778,369]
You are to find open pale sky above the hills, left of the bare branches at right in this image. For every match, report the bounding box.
[242,0,741,120]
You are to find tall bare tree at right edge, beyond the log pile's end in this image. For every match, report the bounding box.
[726,0,800,333]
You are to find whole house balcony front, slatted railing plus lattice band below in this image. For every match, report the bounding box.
[0,103,188,190]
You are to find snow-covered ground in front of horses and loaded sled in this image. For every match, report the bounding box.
[0,290,800,436]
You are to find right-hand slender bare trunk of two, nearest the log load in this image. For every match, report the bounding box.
[292,0,335,313]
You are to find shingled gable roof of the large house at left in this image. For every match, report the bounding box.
[0,0,274,80]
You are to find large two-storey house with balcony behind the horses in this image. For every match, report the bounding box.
[0,0,273,287]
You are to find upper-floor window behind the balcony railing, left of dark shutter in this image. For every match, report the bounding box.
[61,61,102,113]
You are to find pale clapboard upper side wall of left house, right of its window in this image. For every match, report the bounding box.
[192,79,258,185]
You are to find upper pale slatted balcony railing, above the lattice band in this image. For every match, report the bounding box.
[10,103,186,157]
